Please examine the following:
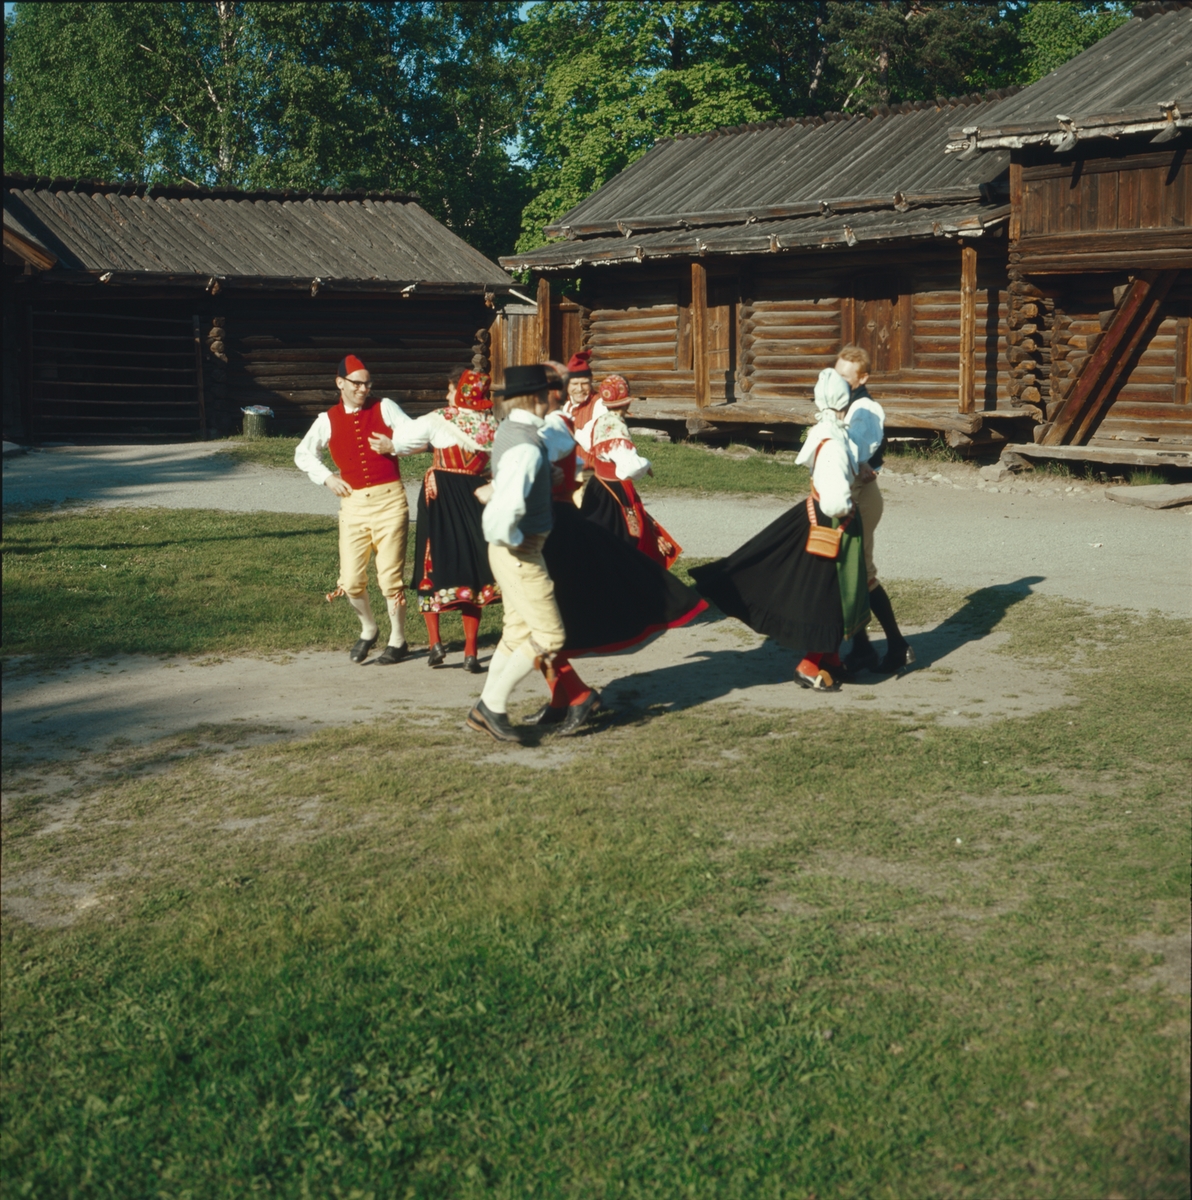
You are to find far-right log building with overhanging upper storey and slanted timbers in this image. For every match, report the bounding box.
[948,2,1192,467]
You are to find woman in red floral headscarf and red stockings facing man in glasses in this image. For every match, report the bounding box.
[400,370,501,674]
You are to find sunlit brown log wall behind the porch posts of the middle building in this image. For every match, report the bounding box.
[588,242,1011,422]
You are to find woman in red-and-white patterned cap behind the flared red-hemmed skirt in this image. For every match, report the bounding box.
[568,374,683,568]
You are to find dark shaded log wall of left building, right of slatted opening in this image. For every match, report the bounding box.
[226,296,492,432]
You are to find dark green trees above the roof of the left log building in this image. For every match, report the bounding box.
[5,2,526,256]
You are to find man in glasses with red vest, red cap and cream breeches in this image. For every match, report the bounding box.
[294,354,409,666]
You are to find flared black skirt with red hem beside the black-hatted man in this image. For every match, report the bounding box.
[543,504,707,656]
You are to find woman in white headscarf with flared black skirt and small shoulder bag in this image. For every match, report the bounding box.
[691,367,869,691]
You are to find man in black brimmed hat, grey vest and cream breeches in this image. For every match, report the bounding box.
[468,364,600,742]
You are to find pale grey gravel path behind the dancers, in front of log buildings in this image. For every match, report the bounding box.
[4,443,1192,616]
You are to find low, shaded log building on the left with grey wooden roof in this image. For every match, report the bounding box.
[4,176,513,442]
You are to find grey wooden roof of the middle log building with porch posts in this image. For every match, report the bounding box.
[502,90,1012,270]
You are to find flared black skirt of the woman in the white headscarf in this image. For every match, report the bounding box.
[691,500,844,655]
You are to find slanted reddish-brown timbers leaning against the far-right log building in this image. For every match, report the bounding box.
[1040,271,1180,446]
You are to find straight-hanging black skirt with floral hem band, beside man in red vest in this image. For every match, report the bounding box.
[414,470,501,612]
